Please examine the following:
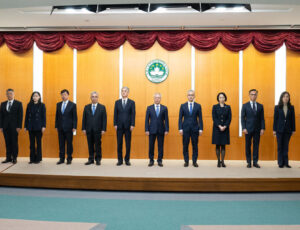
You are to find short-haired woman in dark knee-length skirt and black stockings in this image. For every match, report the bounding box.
[212,92,231,167]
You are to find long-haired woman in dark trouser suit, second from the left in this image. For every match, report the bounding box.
[25,91,46,164]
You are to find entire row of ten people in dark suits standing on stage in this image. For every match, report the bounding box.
[0,87,295,168]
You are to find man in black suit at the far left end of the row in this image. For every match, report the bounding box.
[0,89,23,164]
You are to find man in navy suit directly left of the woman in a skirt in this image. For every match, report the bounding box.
[178,90,203,167]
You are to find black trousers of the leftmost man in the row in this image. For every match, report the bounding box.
[3,128,19,161]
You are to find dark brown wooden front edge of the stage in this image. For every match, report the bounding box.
[0,173,300,192]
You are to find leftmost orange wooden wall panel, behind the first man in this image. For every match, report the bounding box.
[0,44,33,157]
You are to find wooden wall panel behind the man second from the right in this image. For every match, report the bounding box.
[243,45,276,160]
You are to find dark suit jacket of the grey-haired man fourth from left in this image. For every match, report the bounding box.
[82,103,107,133]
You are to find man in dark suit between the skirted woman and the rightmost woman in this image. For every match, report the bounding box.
[241,89,265,168]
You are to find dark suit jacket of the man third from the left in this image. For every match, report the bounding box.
[55,101,77,132]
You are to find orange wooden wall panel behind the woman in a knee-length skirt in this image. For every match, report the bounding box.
[195,44,244,160]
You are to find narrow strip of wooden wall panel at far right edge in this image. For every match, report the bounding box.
[286,50,300,160]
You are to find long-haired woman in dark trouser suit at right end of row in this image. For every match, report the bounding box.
[273,91,296,168]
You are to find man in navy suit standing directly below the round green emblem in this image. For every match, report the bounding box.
[145,93,169,167]
